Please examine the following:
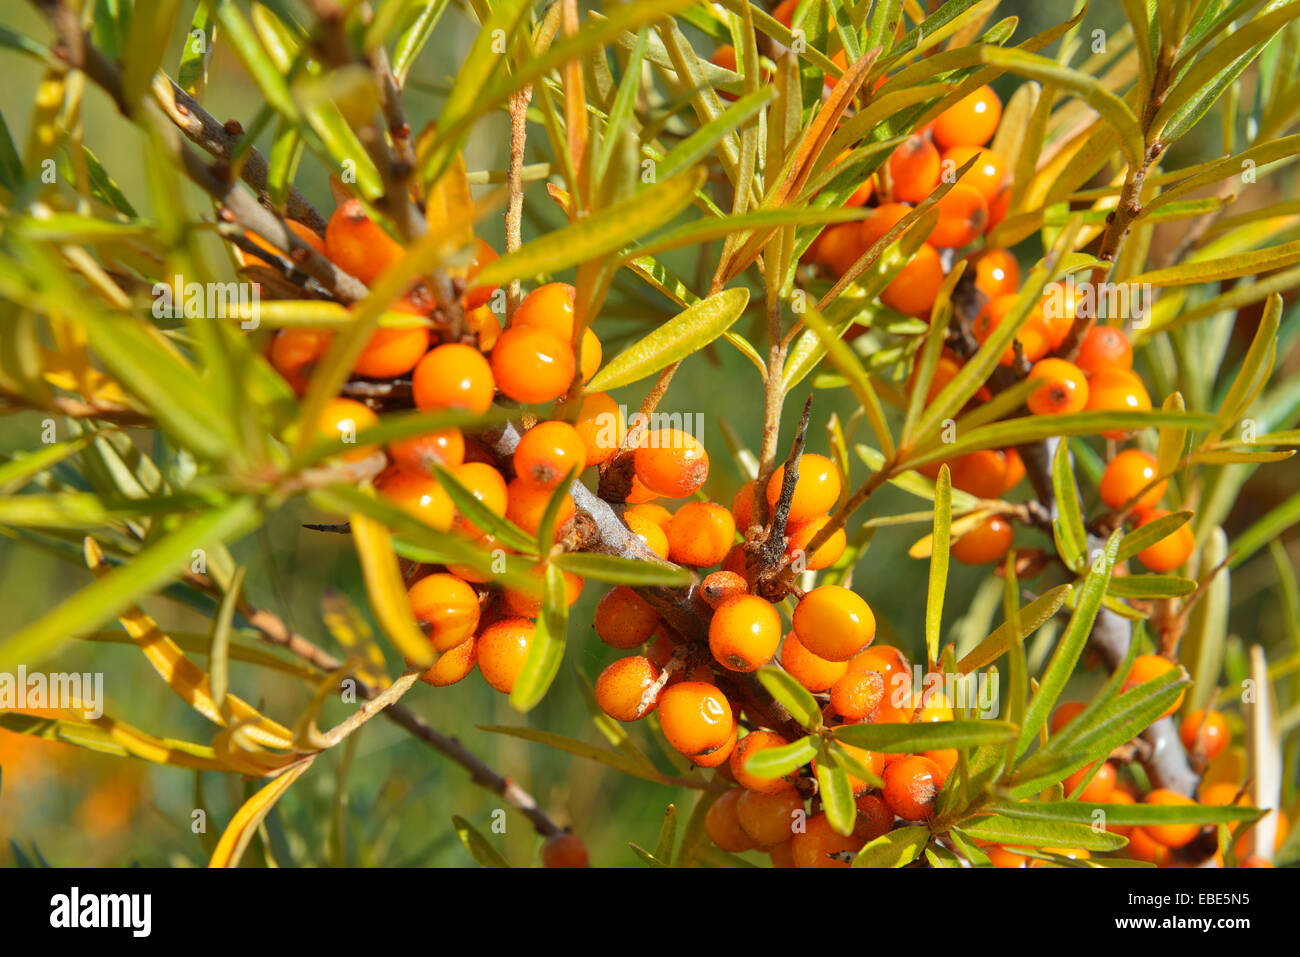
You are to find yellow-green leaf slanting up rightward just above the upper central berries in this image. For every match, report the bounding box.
[477,169,706,286]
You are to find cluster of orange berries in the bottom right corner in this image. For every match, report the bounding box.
[984,686,1290,867]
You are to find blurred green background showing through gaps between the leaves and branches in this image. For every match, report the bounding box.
[0,0,1297,866]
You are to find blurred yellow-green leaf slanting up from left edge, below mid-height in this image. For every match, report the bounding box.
[0,499,259,668]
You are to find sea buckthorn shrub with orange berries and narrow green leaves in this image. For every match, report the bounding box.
[0,0,1300,869]
